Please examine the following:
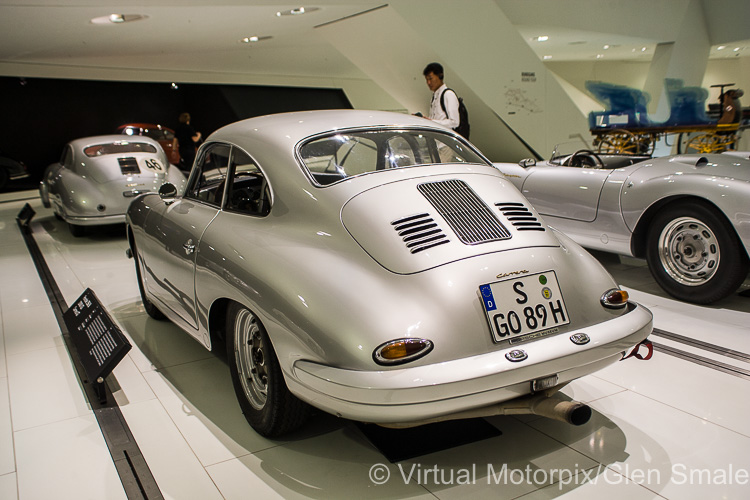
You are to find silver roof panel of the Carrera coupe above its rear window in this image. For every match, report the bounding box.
[207,109,450,147]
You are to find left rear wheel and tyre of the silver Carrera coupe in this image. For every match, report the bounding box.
[227,303,309,437]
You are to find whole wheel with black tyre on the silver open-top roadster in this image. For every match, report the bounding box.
[646,203,748,304]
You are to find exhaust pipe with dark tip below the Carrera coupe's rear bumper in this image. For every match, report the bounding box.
[378,384,592,429]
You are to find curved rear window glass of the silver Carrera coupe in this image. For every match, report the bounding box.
[299,129,488,186]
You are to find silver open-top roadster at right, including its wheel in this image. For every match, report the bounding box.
[495,145,750,304]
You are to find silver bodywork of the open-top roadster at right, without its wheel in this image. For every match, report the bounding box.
[495,154,750,257]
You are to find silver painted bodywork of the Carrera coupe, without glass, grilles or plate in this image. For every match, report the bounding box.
[127,111,652,422]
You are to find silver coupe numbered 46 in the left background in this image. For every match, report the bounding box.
[39,135,186,236]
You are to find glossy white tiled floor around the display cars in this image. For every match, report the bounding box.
[0,192,750,500]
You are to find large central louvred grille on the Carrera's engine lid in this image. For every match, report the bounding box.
[417,179,511,245]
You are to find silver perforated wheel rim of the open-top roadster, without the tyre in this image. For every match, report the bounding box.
[659,217,721,286]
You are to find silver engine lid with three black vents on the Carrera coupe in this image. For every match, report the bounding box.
[341,174,559,274]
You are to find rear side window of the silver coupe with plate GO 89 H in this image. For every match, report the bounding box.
[225,148,271,216]
